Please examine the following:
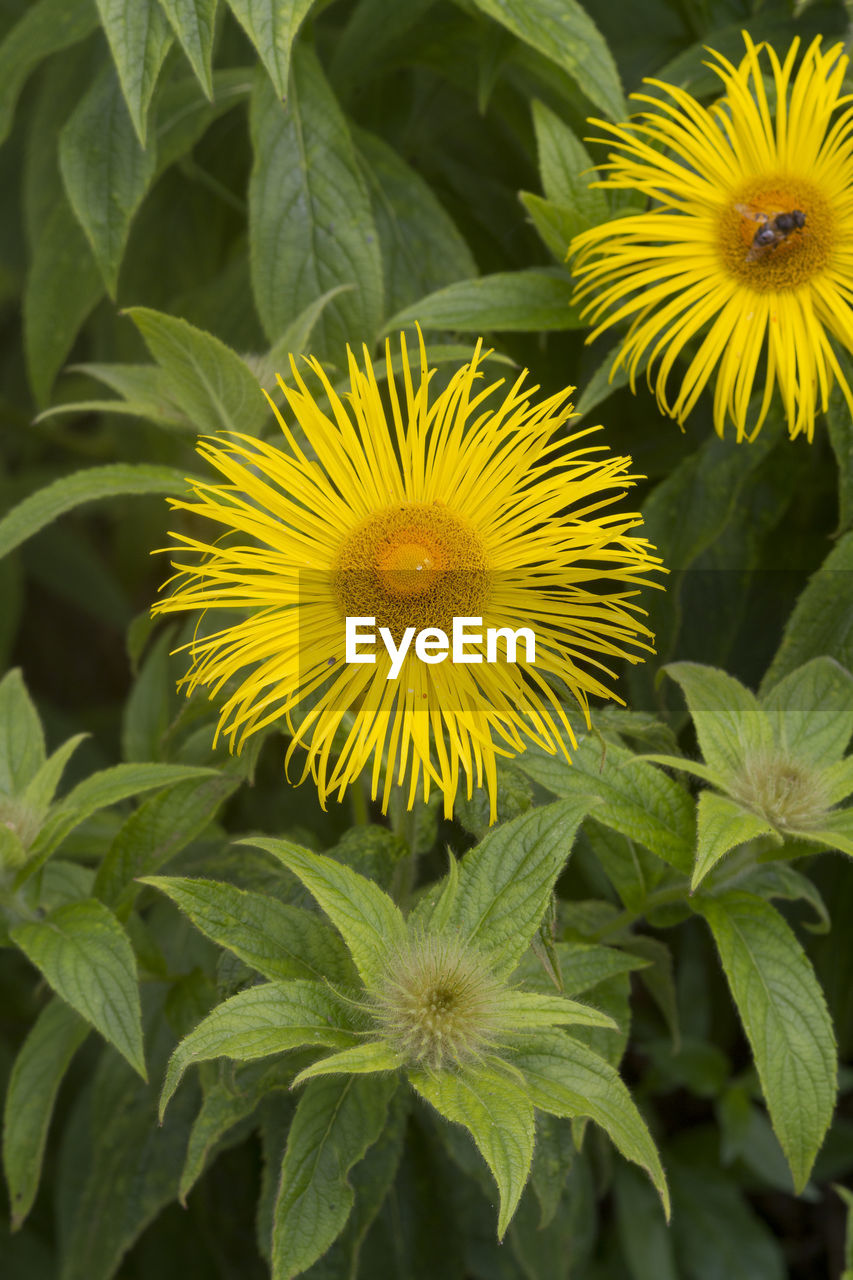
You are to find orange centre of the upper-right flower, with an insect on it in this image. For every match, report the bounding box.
[719,177,836,293]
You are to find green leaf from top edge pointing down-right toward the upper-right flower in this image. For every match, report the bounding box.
[474,0,628,120]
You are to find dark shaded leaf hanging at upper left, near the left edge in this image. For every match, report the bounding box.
[23,192,104,407]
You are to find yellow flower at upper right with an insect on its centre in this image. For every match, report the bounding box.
[570,33,853,440]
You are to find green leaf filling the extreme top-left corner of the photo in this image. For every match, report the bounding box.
[0,0,97,142]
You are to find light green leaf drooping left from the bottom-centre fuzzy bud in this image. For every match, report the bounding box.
[160,978,357,1116]
